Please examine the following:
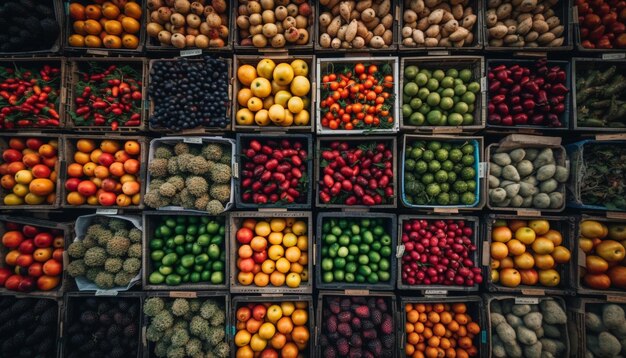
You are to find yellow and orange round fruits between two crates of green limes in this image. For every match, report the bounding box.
[236,218,309,288]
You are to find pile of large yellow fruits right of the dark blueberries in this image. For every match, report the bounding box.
[236,58,311,127]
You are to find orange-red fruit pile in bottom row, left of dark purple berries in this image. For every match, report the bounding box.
[235,301,310,358]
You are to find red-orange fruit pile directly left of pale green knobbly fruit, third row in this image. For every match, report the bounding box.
[65,139,141,207]
